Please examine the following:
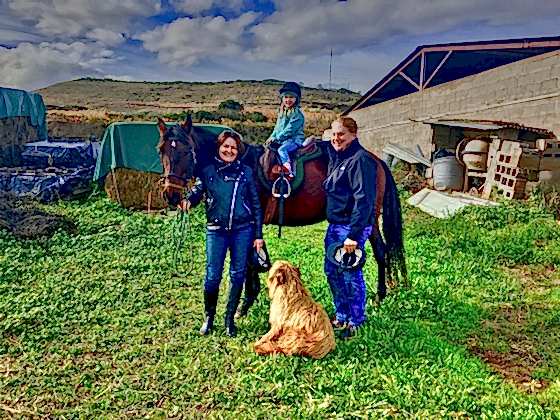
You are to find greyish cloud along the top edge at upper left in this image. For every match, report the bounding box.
[6,0,161,37]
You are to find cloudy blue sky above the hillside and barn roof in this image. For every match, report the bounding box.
[0,0,560,92]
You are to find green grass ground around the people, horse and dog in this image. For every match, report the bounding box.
[0,198,560,419]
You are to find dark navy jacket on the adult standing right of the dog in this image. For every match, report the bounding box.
[323,139,377,241]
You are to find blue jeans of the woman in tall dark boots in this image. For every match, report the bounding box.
[204,225,254,293]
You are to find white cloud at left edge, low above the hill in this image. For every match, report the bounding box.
[0,42,117,89]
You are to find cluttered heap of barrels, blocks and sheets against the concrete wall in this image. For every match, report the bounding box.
[383,120,560,217]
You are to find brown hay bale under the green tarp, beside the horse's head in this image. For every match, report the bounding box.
[105,168,167,210]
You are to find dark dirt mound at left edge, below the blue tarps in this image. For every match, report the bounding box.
[0,192,76,239]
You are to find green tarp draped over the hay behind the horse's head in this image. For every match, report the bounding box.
[93,122,230,180]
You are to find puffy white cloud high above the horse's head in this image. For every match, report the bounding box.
[137,12,258,66]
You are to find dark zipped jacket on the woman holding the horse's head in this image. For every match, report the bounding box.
[187,159,262,239]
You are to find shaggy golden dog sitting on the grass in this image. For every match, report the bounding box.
[254,261,336,359]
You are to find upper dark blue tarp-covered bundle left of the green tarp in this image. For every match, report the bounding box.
[21,141,95,168]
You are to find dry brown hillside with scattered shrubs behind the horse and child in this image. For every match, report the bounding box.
[42,79,360,143]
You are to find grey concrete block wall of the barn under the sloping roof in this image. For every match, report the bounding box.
[349,51,560,156]
